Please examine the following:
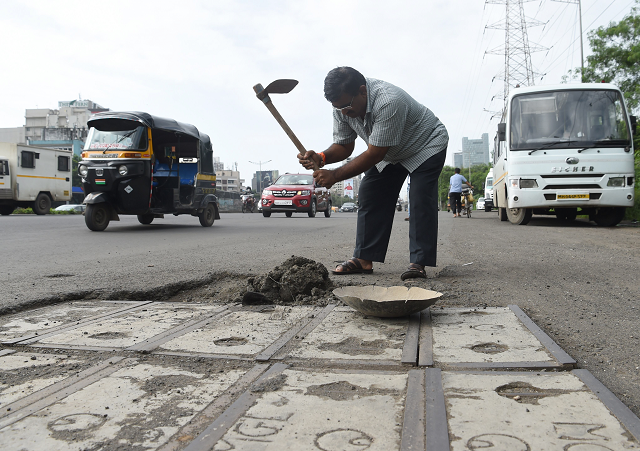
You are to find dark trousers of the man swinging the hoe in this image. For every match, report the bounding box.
[353,149,447,266]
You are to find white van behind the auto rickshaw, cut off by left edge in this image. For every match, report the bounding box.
[0,143,73,215]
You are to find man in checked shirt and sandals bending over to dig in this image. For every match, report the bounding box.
[298,67,449,280]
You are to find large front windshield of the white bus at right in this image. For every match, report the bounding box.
[510,90,631,150]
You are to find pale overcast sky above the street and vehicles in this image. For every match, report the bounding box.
[0,0,634,185]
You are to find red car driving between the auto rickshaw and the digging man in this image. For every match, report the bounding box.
[260,174,331,218]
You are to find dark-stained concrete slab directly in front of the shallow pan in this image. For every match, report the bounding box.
[287,307,409,364]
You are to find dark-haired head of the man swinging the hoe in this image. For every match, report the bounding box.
[324,66,367,117]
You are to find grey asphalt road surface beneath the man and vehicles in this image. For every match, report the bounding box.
[0,211,640,416]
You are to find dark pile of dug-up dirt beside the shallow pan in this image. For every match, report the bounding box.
[243,255,333,305]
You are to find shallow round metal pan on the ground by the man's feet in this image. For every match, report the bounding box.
[333,285,442,318]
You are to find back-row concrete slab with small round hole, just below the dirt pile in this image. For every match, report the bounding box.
[156,306,314,357]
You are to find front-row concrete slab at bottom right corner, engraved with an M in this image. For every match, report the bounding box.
[442,370,640,451]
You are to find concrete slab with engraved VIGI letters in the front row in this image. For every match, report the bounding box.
[191,365,408,451]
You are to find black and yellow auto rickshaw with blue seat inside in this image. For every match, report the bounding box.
[78,111,220,231]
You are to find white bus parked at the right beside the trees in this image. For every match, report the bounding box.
[493,83,636,227]
